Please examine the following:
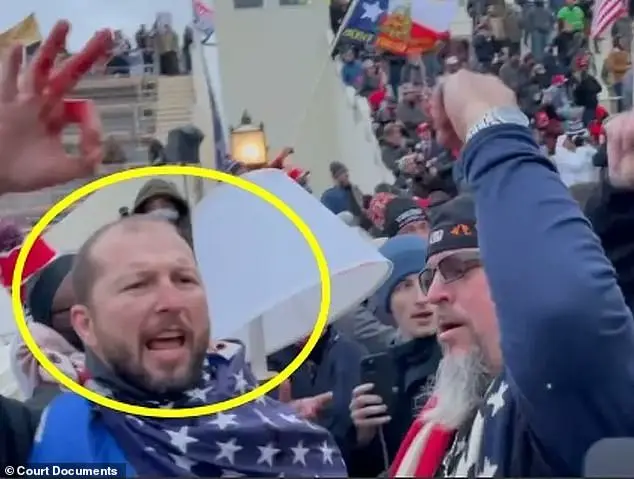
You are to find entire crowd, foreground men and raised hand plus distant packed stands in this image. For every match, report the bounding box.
[0,0,634,477]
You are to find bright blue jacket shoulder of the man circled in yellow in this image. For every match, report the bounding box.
[29,393,136,477]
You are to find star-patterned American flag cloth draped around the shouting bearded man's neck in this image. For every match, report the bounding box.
[88,343,347,477]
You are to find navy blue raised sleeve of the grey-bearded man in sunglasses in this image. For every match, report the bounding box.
[462,125,634,477]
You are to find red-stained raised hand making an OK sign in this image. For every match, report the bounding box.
[0,21,112,194]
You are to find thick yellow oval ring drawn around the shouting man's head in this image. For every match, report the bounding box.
[11,165,331,418]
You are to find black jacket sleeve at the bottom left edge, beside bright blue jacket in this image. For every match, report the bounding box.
[0,396,40,471]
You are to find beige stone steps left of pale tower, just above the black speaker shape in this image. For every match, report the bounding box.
[155,75,195,144]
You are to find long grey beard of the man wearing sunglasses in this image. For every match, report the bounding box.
[423,348,490,429]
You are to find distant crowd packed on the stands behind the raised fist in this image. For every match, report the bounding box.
[331,0,632,206]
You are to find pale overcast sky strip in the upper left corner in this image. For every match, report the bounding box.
[0,0,192,51]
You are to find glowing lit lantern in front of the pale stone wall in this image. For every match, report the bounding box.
[229,110,268,170]
